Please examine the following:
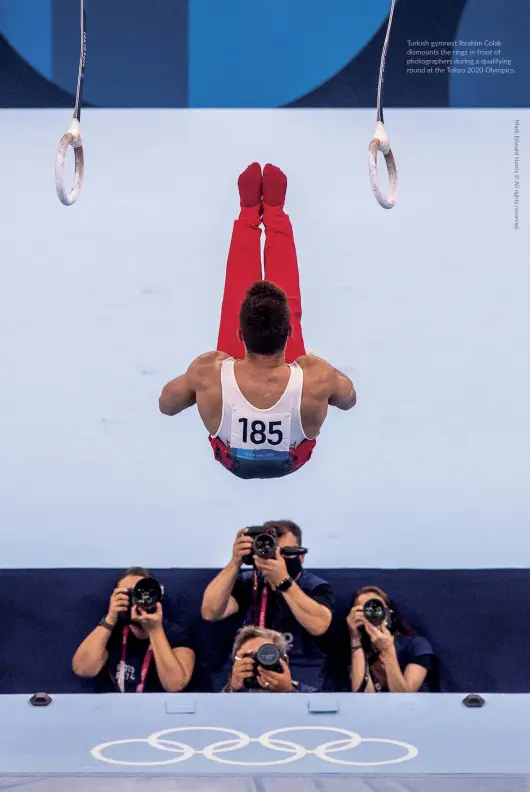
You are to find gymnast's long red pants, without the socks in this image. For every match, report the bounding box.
[210,205,316,472]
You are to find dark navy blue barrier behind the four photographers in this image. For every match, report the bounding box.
[0,569,530,693]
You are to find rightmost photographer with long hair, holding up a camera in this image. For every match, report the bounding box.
[347,586,434,693]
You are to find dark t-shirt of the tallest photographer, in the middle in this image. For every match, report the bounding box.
[232,569,334,689]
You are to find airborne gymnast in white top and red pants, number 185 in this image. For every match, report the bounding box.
[159,162,356,479]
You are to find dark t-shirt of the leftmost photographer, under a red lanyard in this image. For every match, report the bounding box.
[101,622,194,693]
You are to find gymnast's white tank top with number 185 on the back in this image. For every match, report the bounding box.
[214,358,307,462]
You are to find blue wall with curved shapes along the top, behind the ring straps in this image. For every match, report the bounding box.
[0,0,530,108]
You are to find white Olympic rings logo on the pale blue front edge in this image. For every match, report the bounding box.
[90,726,418,767]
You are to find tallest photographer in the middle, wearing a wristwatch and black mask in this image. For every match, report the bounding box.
[201,520,333,688]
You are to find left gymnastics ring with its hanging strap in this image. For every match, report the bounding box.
[55,0,86,206]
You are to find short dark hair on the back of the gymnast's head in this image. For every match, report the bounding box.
[239,280,291,355]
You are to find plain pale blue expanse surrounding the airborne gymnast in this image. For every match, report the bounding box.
[0,110,530,568]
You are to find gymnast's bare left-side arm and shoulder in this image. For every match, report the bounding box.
[158,352,229,415]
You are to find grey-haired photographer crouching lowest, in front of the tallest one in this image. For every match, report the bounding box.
[222,625,315,693]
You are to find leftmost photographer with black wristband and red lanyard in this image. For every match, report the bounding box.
[72,567,195,693]
